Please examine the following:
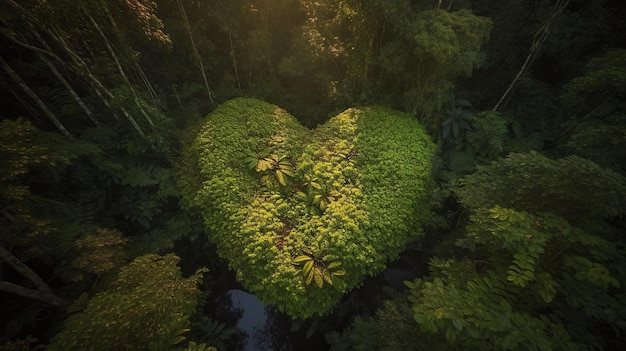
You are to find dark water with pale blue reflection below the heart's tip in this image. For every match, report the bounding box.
[210,250,425,351]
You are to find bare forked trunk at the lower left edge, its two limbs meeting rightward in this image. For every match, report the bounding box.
[0,244,68,308]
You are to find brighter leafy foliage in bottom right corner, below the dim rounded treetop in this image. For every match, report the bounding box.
[398,206,626,350]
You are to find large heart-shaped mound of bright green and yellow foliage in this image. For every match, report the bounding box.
[179,99,434,318]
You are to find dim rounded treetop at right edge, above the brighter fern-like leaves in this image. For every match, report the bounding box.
[457,152,626,220]
